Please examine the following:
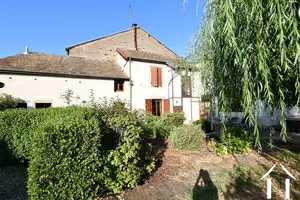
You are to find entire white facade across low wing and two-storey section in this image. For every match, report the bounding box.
[0,55,199,122]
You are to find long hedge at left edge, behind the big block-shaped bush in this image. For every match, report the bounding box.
[0,106,95,161]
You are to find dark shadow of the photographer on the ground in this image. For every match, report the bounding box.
[192,169,218,200]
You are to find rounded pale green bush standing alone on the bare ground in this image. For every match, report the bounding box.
[170,124,205,150]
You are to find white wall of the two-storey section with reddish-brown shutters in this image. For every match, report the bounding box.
[118,55,200,122]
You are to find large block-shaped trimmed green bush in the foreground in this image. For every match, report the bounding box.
[28,114,105,199]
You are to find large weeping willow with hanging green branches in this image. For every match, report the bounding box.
[193,0,300,144]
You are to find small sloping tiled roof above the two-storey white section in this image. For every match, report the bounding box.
[116,48,175,63]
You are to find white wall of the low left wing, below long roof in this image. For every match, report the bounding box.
[0,74,129,107]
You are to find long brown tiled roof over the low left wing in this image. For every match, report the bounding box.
[0,53,129,79]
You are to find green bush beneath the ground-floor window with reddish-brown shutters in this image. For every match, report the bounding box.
[146,112,186,138]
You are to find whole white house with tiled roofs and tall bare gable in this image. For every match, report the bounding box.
[0,24,207,121]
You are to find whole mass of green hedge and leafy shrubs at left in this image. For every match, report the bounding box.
[0,100,154,199]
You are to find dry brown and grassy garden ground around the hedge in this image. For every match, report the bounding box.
[0,141,300,200]
